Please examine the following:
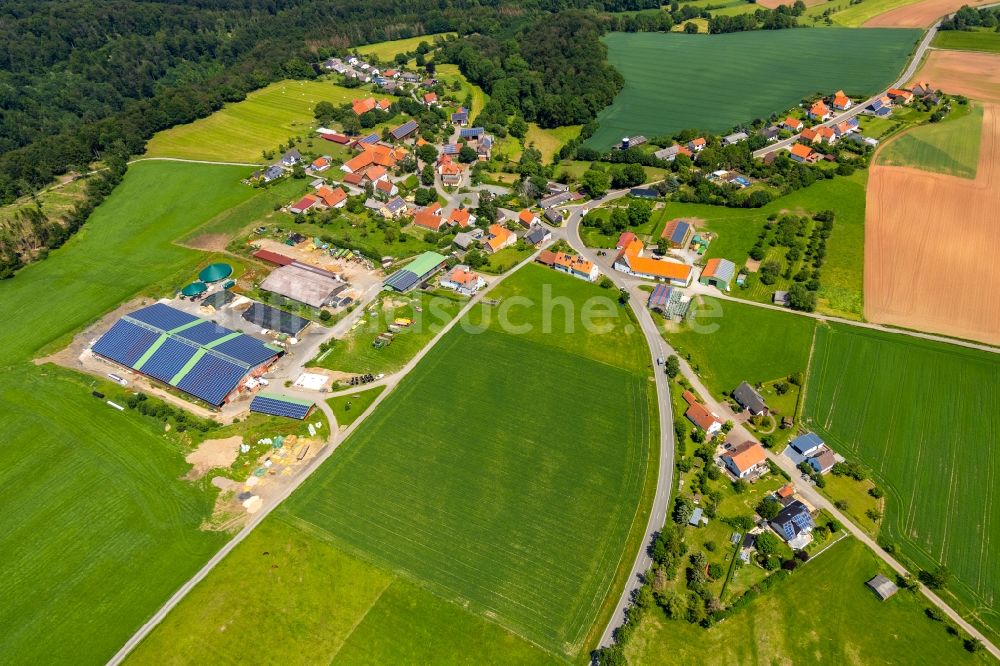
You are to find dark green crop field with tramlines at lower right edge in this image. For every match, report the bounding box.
[805,326,1000,637]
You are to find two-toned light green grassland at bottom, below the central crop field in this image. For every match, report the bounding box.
[129,517,558,665]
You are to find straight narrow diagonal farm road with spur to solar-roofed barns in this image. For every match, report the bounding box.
[108,252,538,665]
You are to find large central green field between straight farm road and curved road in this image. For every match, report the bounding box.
[281,266,652,657]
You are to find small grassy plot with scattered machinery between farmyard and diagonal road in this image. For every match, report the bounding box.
[310,290,467,374]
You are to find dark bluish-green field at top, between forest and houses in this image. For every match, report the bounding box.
[586,28,920,149]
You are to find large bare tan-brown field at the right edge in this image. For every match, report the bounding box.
[865,104,1000,344]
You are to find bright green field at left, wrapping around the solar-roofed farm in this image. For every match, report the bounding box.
[0,162,255,663]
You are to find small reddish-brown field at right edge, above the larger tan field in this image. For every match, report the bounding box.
[913,51,1000,104]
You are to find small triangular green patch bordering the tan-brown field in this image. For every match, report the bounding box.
[878,104,983,178]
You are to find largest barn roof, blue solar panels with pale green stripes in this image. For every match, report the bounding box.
[91,303,283,406]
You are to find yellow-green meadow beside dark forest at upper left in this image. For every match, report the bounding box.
[146,80,390,163]
